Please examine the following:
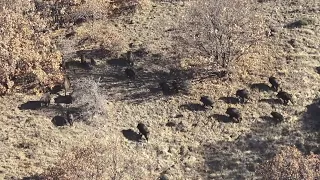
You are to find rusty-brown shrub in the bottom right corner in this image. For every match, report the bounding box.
[258,147,320,180]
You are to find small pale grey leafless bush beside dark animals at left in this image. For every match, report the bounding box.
[73,77,106,120]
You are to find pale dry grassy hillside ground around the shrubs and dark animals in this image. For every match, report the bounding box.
[0,0,320,179]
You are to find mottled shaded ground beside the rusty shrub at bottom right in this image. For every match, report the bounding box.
[203,121,320,180]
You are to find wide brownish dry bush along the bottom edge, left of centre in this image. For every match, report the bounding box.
[37,136,156,180]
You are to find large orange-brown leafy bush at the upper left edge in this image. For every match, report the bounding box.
[0,1,62,94]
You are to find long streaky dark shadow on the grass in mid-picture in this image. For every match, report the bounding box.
[65,49,230,103]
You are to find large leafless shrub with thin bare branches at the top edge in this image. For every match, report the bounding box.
[177,0,264,67]
